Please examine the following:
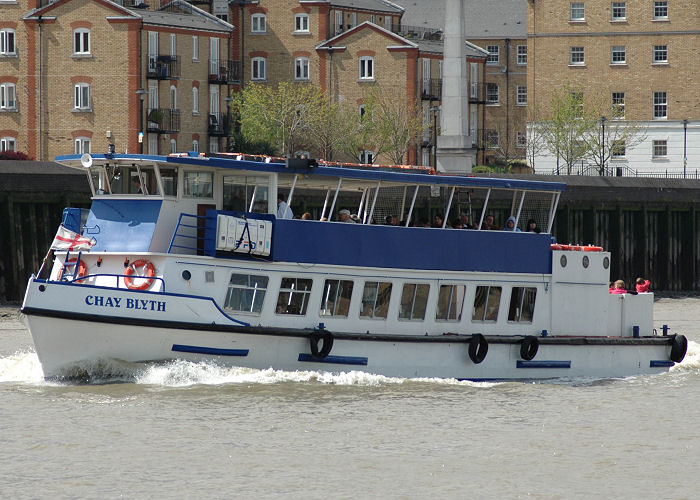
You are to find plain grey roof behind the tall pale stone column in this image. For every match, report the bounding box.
[394,0,527,39]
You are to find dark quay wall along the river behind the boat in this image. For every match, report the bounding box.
[0,161,700,303]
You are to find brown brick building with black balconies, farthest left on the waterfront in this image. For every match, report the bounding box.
[0,0,238,160]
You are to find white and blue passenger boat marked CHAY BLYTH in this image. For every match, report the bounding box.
[22,154,687,381]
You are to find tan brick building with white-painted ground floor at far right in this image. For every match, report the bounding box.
[527,0,700,175]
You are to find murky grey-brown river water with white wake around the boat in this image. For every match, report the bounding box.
[0,297,700,499]
